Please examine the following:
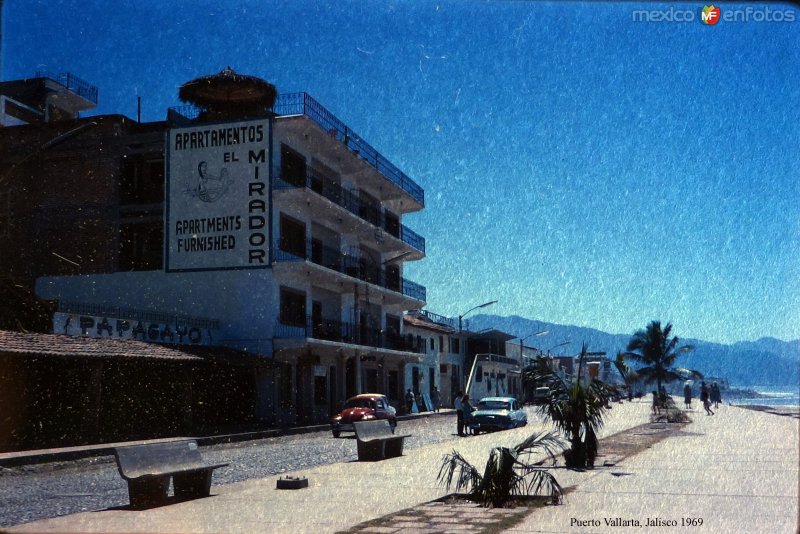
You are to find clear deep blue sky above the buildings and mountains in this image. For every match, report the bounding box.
[2,0,800,343]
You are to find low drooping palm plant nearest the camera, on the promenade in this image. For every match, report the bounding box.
[437,432,564,508]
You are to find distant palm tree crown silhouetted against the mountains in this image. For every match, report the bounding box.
[623,321,703,392]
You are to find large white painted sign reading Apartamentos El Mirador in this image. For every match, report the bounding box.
[164,119,270,272]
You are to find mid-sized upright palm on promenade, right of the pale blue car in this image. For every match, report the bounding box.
[537,343,615,468]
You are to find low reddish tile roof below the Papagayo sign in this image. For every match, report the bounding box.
[0,330,203,361]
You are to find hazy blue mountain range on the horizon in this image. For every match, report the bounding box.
[469,314,800,389]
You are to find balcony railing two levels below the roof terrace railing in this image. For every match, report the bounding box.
[272,240,427,302]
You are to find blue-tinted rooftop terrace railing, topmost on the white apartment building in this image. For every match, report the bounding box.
[273,93,425,206]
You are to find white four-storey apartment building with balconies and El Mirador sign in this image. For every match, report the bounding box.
[37,93,428,430]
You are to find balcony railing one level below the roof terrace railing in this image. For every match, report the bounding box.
[272,167,425,254]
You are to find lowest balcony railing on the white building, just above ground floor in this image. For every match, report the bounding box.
[275,316,421,352]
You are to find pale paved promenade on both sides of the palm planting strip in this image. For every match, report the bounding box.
[9,402,800,533]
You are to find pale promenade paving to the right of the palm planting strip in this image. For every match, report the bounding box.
[506,406,800,534]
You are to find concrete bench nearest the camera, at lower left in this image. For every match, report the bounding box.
[114,440,228,508]
